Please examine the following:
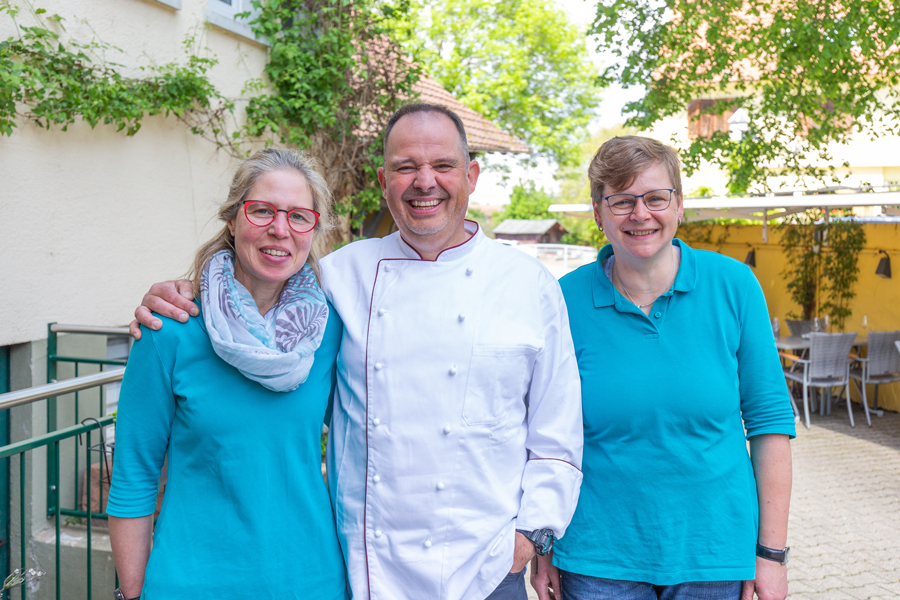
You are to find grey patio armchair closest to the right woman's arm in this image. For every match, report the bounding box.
[778,331,856,429]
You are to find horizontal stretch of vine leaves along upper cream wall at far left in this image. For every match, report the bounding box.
[0,2,233,144]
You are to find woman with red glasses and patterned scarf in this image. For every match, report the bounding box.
[107,149,347,600]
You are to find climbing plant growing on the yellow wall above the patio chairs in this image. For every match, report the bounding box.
[775,209,866,331]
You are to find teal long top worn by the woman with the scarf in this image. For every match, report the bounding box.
[107,308,348,600]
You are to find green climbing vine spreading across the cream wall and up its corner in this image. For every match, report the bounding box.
[0,0,419,238]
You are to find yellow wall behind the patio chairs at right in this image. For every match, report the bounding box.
[685,223,900,411]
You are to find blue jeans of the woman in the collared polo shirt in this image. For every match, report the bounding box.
[559,570,741,600]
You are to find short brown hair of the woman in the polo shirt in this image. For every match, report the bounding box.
[588,135,681,202]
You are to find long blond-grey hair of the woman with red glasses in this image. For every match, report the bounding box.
[188,148,335,297]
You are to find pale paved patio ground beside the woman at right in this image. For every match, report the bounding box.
[528,405,900,600]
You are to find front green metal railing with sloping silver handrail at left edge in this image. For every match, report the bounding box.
[0,369,124,600]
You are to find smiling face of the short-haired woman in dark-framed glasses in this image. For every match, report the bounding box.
[594,163,683,260]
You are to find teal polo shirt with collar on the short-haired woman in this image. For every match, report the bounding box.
[554,240,795,585]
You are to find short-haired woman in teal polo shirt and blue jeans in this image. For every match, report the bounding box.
[533,136,795,600]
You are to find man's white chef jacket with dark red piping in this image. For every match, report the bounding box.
[321,222,583,600]
